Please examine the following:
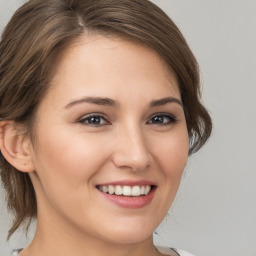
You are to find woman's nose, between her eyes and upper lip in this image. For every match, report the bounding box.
[112,125,151,172]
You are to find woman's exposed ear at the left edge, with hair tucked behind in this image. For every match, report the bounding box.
[0,121,34,172]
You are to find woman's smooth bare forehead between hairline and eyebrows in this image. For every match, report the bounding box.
[44,35,180,106]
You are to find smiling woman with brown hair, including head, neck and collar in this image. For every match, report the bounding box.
[0,0,211,256]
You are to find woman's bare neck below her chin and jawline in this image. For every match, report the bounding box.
[20,214,159,256]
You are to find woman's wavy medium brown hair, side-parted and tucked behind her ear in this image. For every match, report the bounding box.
[0,0,212,237]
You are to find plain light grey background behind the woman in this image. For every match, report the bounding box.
[0,0,256,256]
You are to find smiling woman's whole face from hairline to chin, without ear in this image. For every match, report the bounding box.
[31,36,189,243]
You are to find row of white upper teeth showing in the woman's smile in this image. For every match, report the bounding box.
[97,185,151,197]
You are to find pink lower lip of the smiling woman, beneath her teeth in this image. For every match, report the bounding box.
[98,187,156,209]
